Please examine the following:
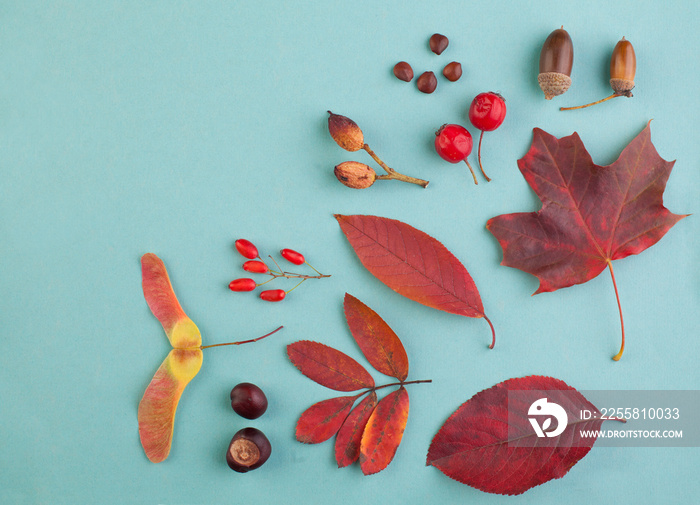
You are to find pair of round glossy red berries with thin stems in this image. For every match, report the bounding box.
[435,92,506,184]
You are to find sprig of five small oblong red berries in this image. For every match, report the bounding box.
[228,238,330,302]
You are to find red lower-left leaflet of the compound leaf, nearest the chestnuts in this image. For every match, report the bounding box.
[296,396,357,444]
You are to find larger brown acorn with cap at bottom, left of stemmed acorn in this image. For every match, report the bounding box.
[537,26,574,100]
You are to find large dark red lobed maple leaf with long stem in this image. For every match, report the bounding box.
[486,123,686,361]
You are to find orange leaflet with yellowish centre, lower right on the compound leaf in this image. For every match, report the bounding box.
[360,386,408,475]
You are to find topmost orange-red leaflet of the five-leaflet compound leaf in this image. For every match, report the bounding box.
[344,293,408,381]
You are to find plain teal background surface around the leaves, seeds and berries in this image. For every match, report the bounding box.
[0,0,700,504]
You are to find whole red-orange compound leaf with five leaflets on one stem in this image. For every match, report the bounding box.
[287,293,431,475]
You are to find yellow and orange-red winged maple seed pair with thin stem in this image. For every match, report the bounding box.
[138,253,282,463]
